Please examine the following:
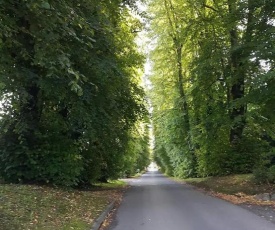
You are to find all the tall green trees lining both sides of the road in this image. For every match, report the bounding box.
[0,0,275,186]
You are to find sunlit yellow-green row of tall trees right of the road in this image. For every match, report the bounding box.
[150,0,275,177]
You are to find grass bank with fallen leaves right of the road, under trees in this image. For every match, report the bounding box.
[177,174,275,195]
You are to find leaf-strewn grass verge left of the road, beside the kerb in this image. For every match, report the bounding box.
[0,181,125,230]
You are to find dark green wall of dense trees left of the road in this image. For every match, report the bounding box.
[0,0,148,185]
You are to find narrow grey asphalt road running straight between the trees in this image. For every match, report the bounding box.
[109,172,275,230]
